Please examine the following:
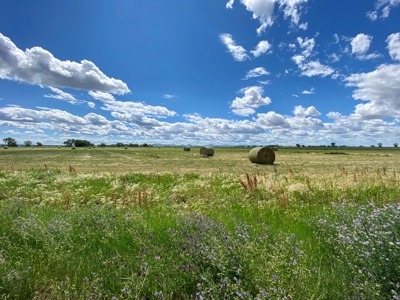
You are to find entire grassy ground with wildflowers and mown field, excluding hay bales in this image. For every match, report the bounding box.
[0,147,400,299]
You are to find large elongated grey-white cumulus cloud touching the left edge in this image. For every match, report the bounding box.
[0,33,130,95]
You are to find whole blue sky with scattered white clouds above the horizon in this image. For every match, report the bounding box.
[0,0,400,146]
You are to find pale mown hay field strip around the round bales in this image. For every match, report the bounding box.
[0,147,400,175]
